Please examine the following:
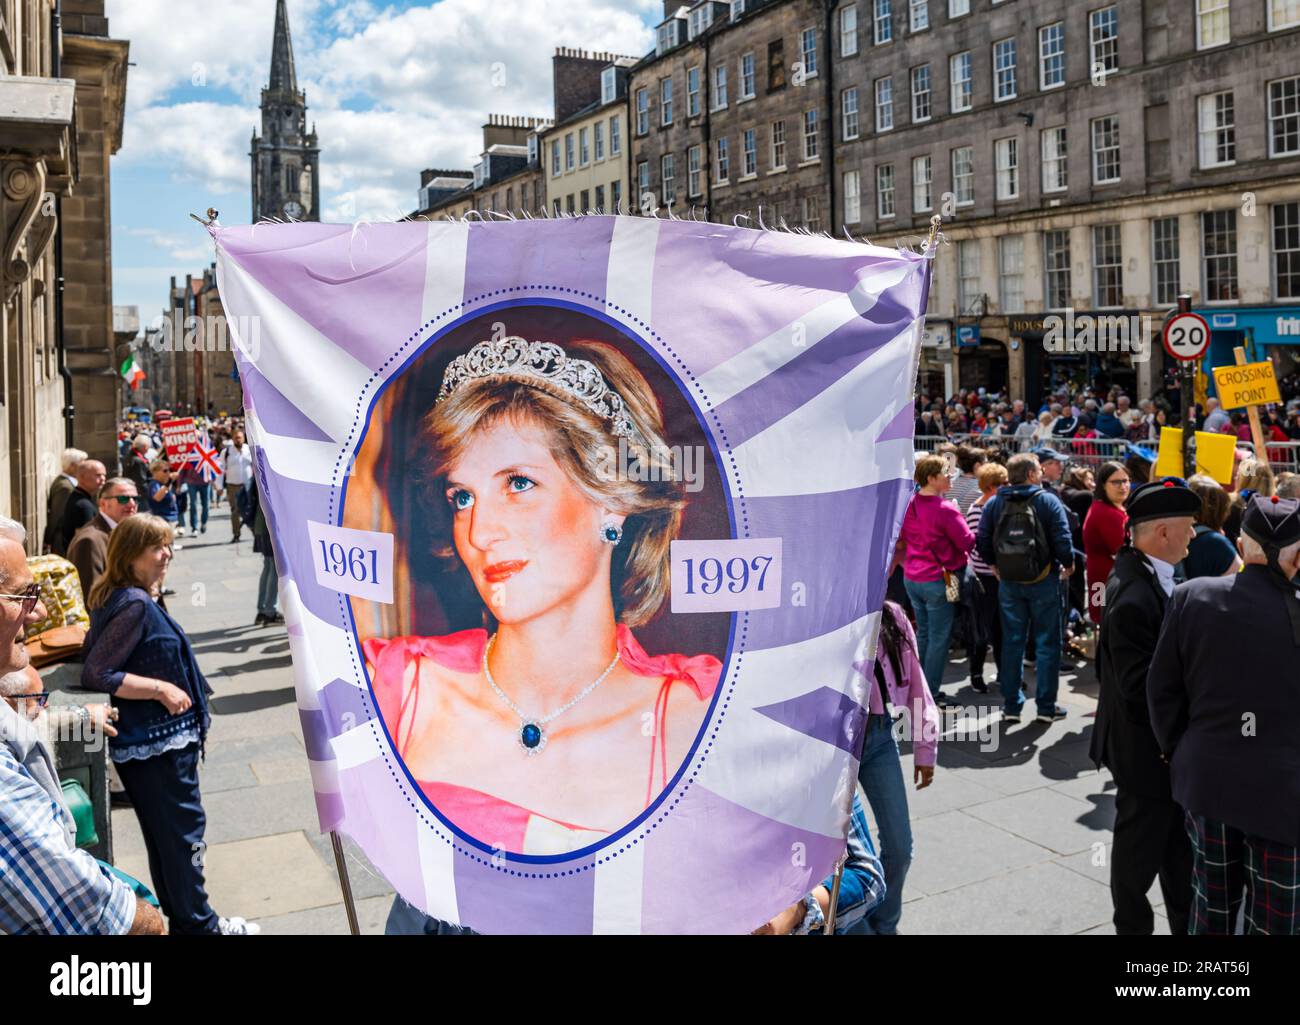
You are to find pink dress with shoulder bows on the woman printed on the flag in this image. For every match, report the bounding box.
[361,623,722,855]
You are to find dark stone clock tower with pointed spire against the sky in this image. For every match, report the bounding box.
[251,0,321,224]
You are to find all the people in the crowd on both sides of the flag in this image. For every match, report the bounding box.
[10,395,1300,935]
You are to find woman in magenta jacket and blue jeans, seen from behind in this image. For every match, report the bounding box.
[898,455,975,708]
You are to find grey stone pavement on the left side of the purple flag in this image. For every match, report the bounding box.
[105,503,393,934]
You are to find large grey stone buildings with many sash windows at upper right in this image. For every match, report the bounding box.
[400,0,1300,403]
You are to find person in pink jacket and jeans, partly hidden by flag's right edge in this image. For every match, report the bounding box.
[858,601,939,935]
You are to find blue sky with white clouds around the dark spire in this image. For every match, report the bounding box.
[107,0,663,323]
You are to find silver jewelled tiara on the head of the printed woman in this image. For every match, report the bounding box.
[434,336,636,438]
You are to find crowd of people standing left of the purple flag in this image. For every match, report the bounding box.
[0,420,283,935]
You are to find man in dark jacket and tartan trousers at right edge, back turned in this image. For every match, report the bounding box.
[1149,498,1300,935]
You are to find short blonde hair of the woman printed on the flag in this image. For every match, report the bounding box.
[424,341,686,627]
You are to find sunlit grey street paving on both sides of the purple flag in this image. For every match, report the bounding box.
[101,505,1169,934]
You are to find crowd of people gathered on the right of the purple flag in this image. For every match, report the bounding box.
[883,395,1300,934]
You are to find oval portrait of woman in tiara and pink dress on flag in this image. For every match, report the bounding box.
[345,311,727,855]
